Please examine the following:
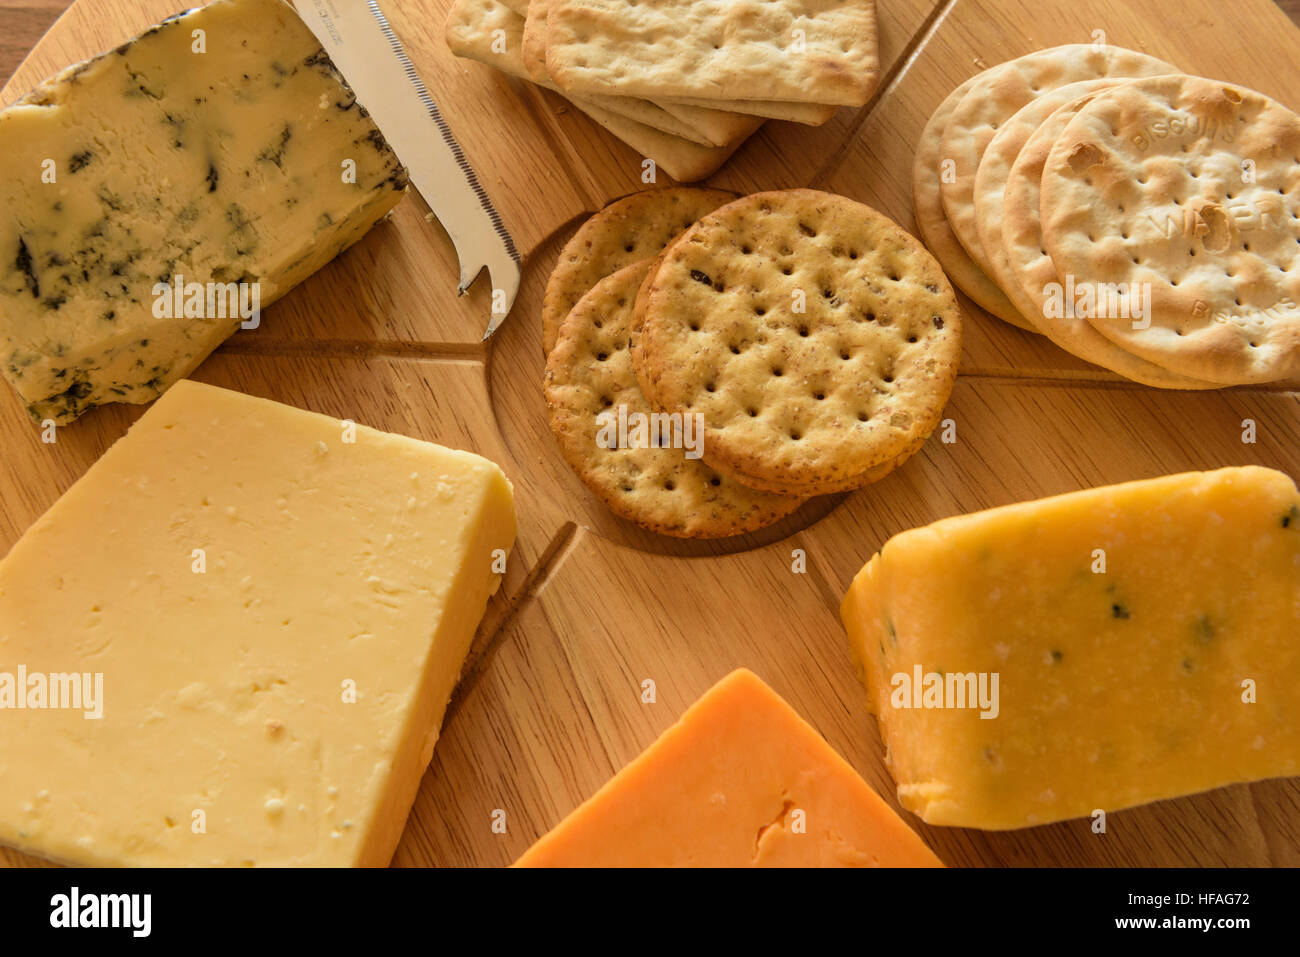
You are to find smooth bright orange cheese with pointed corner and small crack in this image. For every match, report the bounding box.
[515,668,943,867]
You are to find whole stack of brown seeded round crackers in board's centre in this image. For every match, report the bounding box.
[543,189,961,537]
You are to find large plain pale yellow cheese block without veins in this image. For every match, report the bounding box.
[0,380,515,866]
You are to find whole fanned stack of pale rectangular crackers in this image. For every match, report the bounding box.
[446,0,879,182]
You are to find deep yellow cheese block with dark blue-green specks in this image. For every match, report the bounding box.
[841,467,1300,830]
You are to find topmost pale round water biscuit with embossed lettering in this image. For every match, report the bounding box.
[1041,75,1300,385]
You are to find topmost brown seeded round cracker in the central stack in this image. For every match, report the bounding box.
[638,190,961,495]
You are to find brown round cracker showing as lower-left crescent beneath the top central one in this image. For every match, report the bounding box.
[545,261,802,538]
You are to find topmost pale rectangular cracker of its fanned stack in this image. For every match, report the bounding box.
[546,0,879,107]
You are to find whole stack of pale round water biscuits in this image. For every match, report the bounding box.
[913,46,1300,389]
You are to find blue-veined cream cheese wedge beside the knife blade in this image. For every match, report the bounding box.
[0,0,407,423]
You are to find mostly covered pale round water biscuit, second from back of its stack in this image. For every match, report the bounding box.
[940,43,1178,282]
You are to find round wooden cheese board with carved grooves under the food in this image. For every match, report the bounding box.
[0,0,1300,866]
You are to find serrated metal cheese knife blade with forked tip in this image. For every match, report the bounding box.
[291,0,520,339]
